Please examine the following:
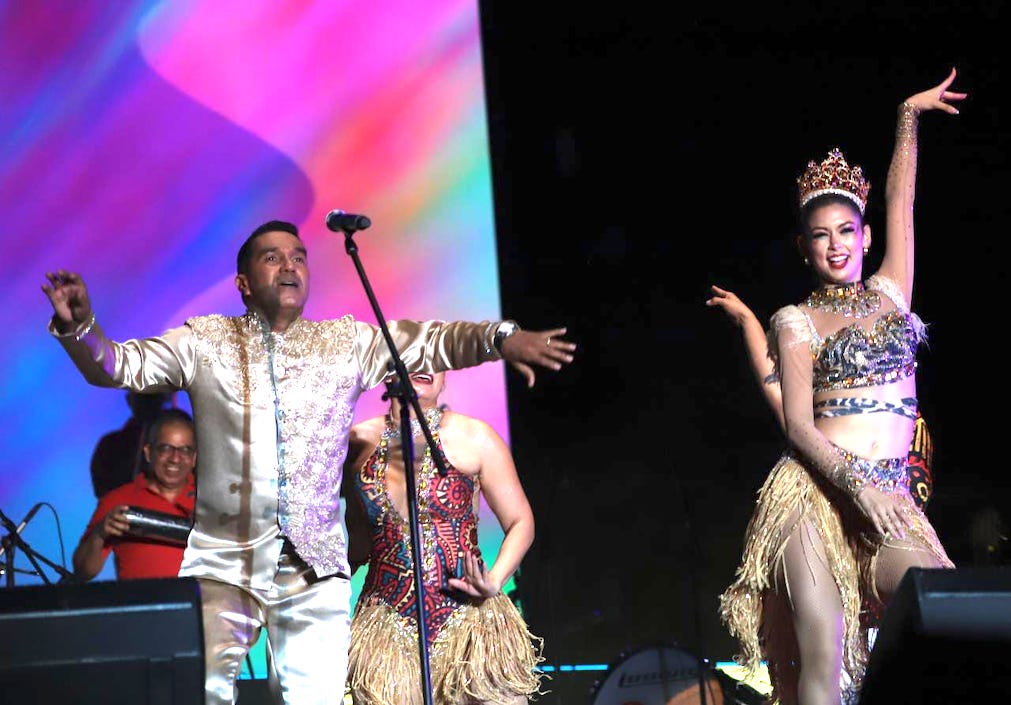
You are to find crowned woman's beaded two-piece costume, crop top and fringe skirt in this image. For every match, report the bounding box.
[720,276,952,702]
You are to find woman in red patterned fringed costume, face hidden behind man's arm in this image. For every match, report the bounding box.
[344,372,541,705]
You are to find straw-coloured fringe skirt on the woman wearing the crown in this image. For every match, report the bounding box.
[720,451,953,702]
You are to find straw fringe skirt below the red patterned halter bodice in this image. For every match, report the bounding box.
[348,595,543,705]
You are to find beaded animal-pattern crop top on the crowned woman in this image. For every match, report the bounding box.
[769,275,926,392]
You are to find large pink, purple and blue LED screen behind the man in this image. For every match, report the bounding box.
[0,0,509,610]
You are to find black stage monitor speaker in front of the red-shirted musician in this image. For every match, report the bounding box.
[0,578,204,705]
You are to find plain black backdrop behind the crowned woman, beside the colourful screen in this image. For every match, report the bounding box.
[482,1,1011,702]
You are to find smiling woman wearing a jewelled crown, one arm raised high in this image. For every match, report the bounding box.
[720,69,966,705]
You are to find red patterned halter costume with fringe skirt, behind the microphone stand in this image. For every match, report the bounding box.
[348,409,540,705]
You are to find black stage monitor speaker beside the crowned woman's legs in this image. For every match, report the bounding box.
[859,565,1011,705]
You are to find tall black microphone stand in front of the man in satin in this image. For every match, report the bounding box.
[341,224,449,705]
